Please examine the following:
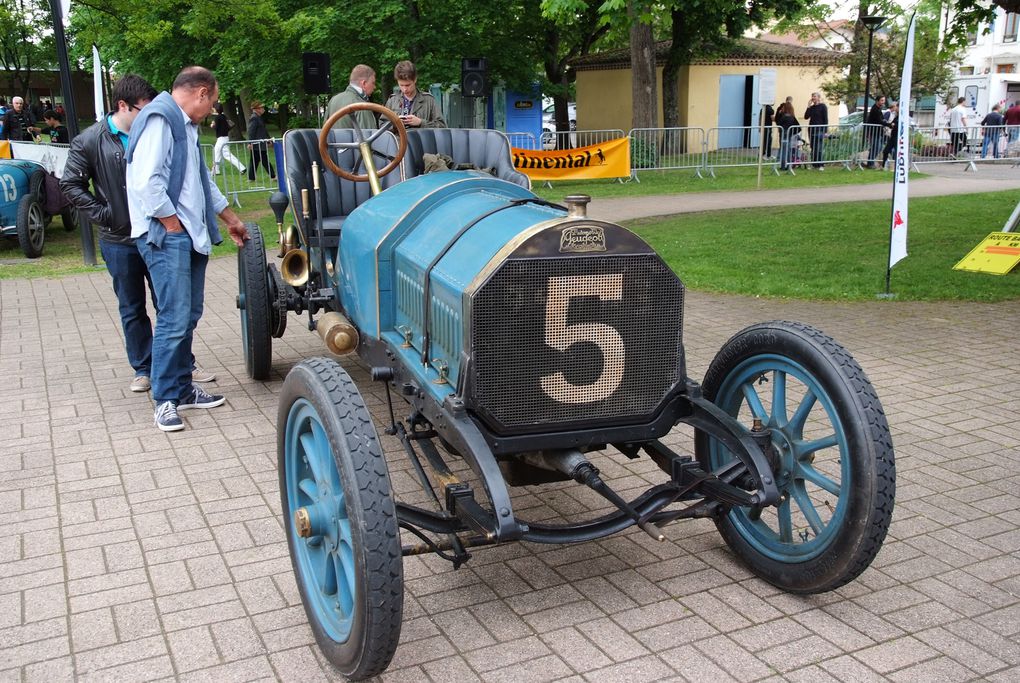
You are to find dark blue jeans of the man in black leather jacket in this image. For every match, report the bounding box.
[99,240,156,377]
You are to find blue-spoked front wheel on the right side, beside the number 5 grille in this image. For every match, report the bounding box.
[696,322,896,593]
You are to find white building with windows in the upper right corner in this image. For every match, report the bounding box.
[935,7,1020,122]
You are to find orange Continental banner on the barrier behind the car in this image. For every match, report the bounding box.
[510,138,630,180]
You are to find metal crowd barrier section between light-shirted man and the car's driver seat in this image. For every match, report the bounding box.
[202,139,283,207]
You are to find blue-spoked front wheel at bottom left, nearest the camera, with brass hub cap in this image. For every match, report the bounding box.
[276,358,404,680]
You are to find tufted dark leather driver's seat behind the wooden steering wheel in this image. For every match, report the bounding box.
[284,128,403,238]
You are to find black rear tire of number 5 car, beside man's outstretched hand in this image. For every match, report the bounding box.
[238,223,272,379]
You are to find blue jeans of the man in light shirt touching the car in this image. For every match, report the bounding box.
[136,232,209,404]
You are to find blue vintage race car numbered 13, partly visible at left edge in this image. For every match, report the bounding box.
[0,159,77,259]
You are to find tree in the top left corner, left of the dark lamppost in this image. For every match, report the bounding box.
[0,0,55,97]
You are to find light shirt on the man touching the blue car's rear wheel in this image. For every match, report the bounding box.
[128,100,228,255]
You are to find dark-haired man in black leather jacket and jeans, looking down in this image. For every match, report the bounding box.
[60,74,215,391]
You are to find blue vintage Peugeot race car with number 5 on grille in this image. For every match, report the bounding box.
[238,102,896,680]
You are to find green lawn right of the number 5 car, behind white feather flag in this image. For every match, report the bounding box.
[628,191,1020,302]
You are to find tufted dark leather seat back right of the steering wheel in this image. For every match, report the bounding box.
[403,128,531,189]
